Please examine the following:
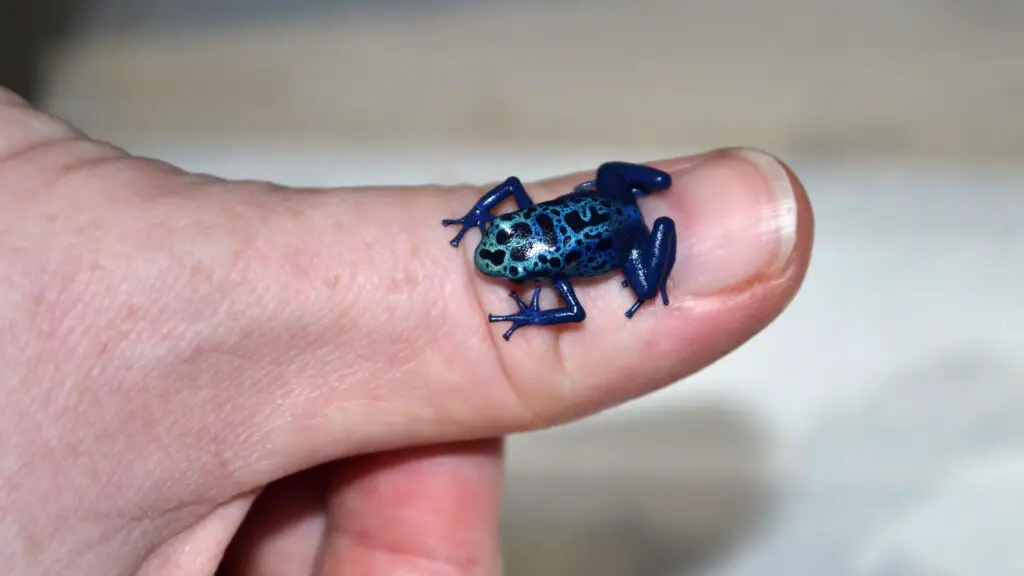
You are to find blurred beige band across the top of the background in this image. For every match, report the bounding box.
[37,0,1024,159]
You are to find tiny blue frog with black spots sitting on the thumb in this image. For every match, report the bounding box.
[441,161,677,341]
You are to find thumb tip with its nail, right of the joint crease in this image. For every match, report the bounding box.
[491,149,813,421]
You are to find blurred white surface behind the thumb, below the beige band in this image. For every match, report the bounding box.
[121,142,1024,576]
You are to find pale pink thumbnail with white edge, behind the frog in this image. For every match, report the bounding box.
[662,149,797,295]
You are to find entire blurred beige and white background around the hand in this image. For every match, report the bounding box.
[0,0,1024,576]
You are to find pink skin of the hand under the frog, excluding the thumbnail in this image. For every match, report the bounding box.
[0,86,813,576]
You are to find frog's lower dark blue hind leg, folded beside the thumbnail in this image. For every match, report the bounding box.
[623,216,676,318]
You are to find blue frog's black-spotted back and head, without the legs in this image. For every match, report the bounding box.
[476,192,643,282]
